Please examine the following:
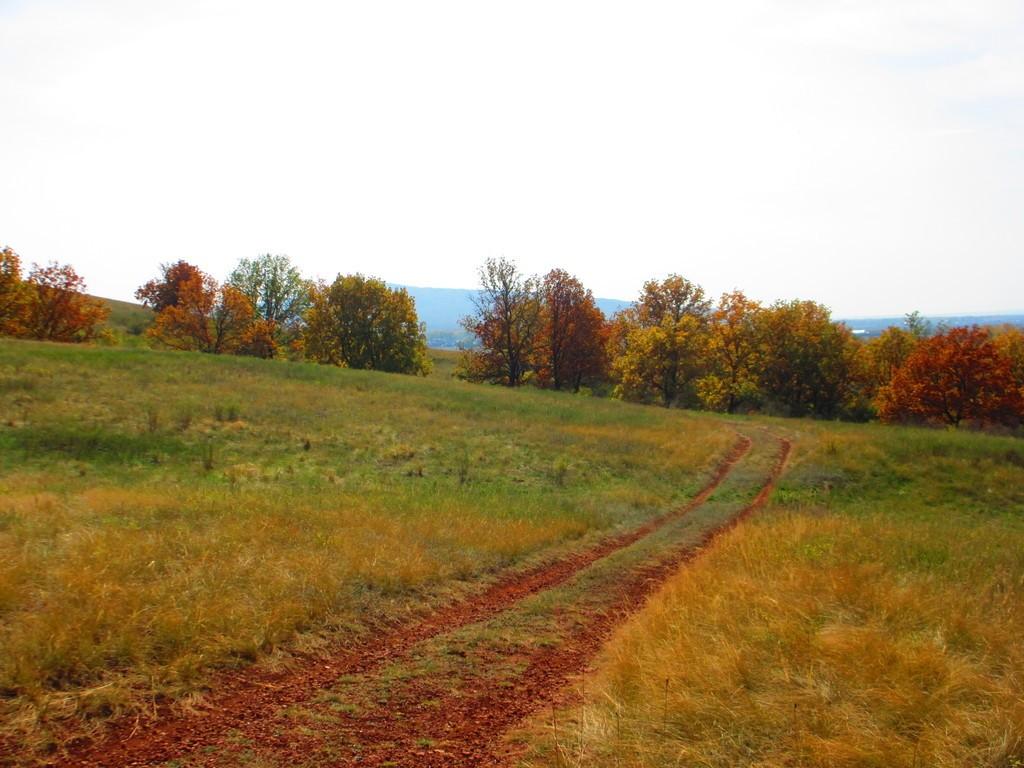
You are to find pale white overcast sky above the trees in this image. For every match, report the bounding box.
[0,0,1024,316]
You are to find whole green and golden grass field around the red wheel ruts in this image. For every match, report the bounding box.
[0,341,1024,768]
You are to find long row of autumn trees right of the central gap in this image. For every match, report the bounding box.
[459,259,1024,434]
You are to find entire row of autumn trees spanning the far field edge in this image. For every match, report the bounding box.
[0,243,1024,427]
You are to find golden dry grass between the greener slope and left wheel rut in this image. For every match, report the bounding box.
[0,487,586,741]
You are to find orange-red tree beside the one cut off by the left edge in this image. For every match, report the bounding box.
[20,261,111,342]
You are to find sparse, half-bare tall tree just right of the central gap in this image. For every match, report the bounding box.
[462,258,542,387]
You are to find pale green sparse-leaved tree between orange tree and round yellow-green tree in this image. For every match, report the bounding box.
[227,253,310,340]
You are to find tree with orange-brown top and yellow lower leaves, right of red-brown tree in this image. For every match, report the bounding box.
[611,274,711,407]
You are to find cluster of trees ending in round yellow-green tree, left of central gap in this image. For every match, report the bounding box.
[135,254,430,374]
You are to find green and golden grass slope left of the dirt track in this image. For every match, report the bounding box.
[0,341,733,742]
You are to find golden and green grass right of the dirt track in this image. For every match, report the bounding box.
[520,424,1024,768]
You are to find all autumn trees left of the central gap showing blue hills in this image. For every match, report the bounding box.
[0,248,430,375]
